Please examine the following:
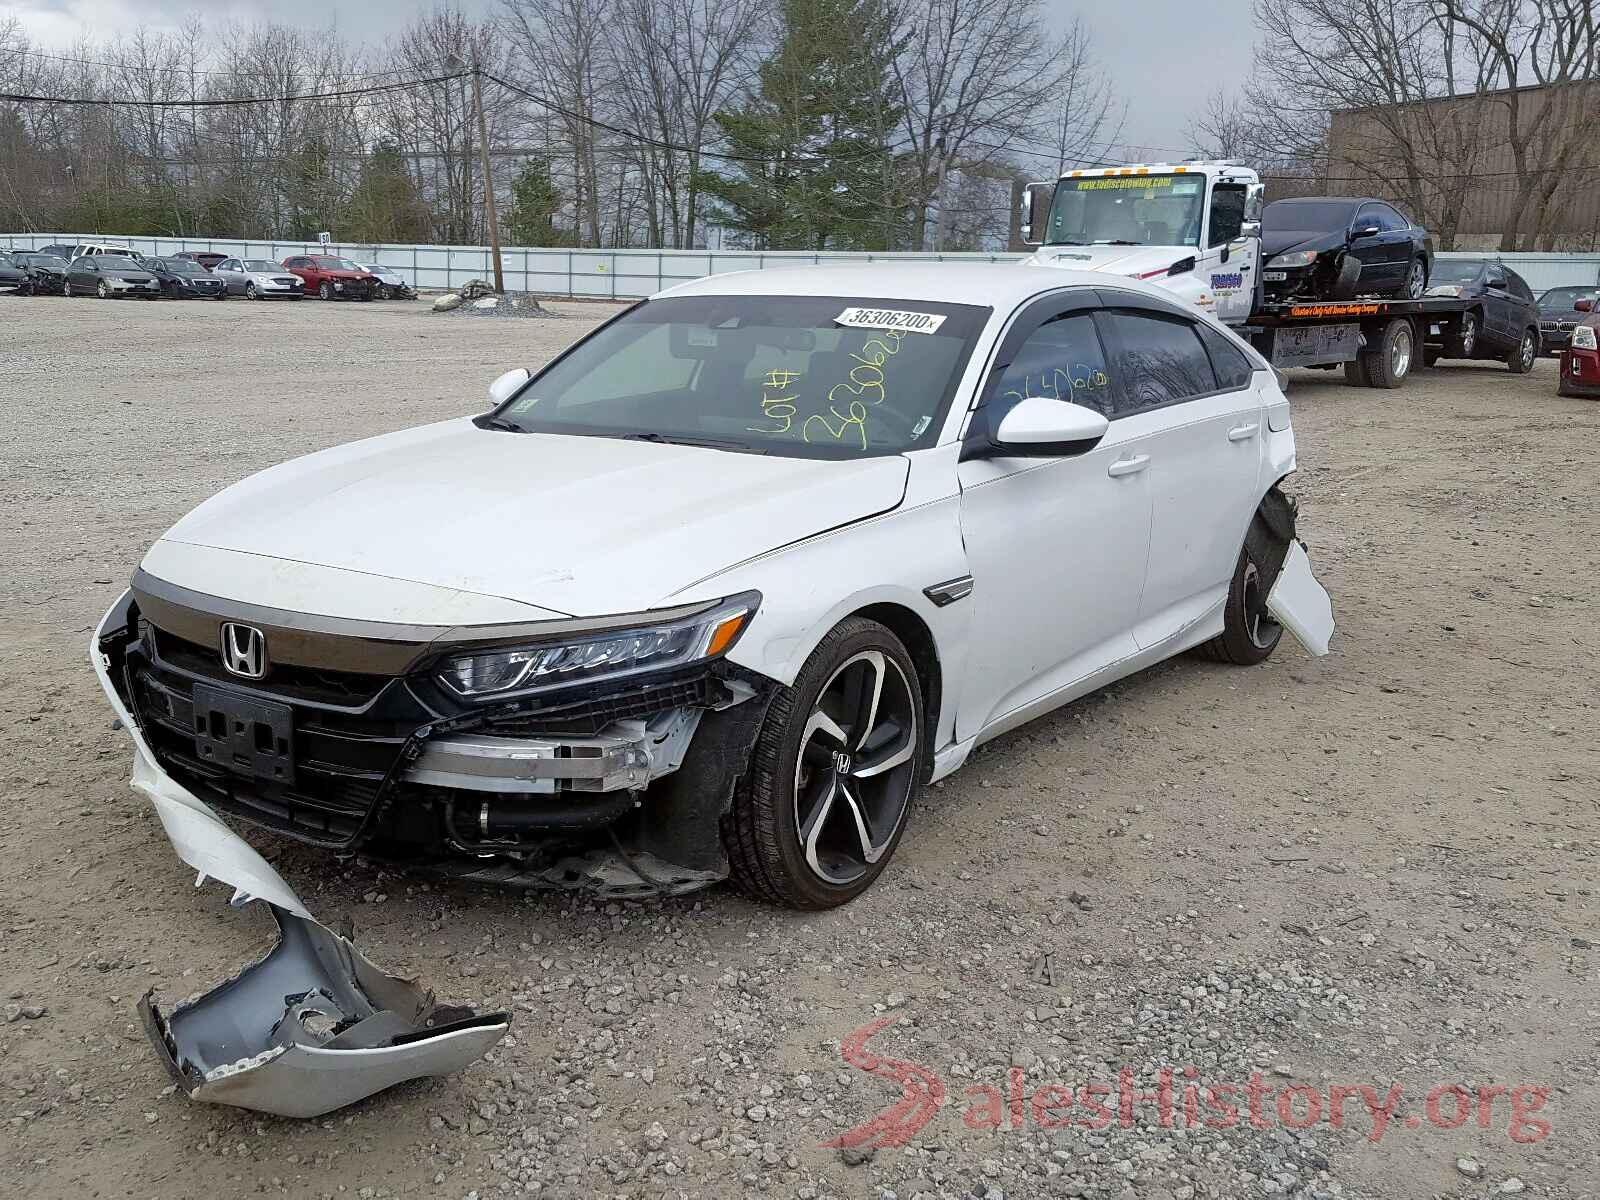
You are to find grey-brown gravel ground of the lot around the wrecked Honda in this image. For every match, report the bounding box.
[0,299,1600,1200]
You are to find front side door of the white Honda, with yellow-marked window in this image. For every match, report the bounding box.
[955,293,1152,739]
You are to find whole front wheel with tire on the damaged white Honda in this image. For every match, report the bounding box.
[722,618,928,910]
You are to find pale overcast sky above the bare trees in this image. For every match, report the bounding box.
[0,0,1254,158]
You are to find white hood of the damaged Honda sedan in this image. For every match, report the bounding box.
[146,419,909,619]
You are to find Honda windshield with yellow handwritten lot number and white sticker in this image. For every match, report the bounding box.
[491,296,990,458]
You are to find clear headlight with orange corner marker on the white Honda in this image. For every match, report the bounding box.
[437,592,762,699]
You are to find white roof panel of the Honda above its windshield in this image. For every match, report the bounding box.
[651,262,1176,310]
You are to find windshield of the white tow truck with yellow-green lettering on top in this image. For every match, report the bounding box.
[1045,174,1205,246]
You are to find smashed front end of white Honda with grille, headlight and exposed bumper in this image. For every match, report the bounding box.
[96,573,773,896]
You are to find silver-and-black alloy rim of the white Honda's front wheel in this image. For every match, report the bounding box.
[795,650,920,886]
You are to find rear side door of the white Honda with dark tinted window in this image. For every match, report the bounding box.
[1096,291,1264,650]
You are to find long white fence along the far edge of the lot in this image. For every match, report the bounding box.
[0,234,1600,299]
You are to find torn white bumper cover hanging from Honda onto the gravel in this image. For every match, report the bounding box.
[90,606,510,1117]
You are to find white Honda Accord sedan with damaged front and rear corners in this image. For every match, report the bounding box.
[91,264,1331,909]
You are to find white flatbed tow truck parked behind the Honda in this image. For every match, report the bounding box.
[1021,158,1469,387]
